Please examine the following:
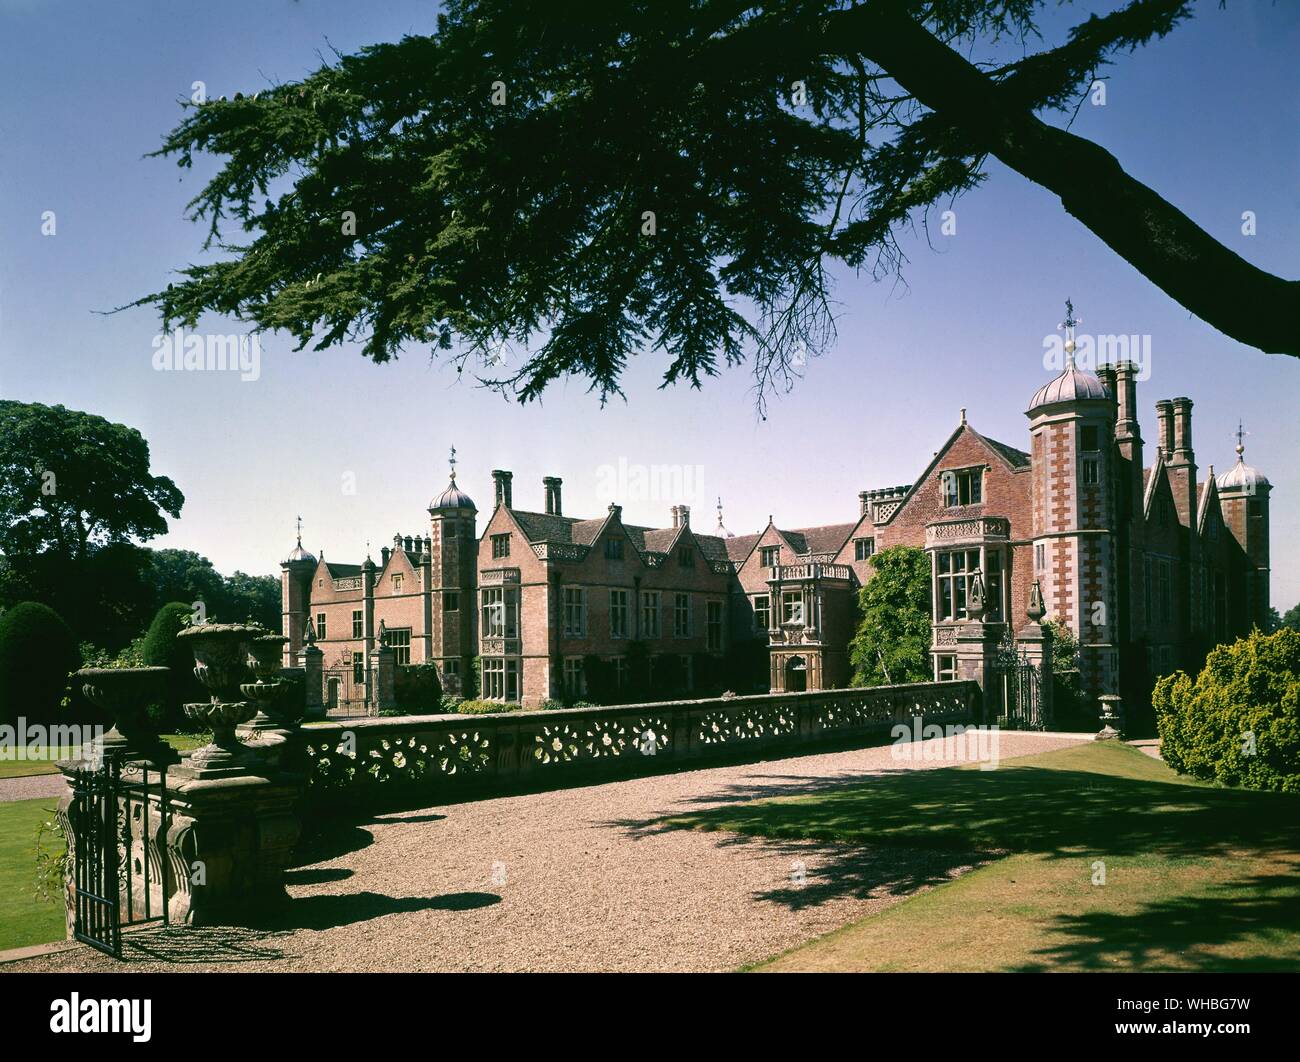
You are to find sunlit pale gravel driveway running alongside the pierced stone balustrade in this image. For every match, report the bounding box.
[0,734,1079,972]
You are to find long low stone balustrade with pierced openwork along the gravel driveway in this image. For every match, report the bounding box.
[302,681,980,802]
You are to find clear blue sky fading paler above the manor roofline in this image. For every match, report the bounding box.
[0,0,1300,608]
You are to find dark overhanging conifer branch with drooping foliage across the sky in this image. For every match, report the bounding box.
[134,0,1300,400]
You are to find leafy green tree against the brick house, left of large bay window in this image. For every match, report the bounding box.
[849,546,933,686]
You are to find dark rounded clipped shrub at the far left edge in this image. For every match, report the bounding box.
[0,601,81,723]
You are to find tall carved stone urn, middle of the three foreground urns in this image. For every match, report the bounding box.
[177,623,264,775]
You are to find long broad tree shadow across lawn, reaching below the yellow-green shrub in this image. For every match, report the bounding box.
[616,753,1300,857]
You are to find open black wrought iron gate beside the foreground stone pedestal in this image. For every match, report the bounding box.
[66,760,169,958]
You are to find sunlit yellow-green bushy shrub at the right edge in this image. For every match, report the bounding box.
[1152,630,1300,793]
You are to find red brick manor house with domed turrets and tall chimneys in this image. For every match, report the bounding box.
[281,339,1271,706]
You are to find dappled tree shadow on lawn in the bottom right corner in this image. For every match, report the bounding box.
[1018,874,1300,972]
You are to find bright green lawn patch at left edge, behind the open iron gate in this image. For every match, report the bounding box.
[0,797,65,952]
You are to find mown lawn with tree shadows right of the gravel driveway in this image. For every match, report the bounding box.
[667,742,1300,971]
